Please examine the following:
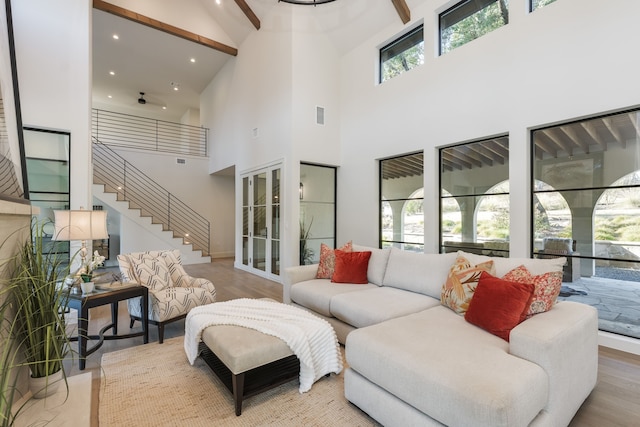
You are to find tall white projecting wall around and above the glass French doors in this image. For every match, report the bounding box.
[200,5,348,266]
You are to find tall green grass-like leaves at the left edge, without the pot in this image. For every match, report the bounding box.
[0,221,70,426]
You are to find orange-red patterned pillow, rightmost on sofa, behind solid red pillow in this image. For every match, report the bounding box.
[502,265,562,317]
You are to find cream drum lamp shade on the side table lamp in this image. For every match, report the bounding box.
[53,209,109,240]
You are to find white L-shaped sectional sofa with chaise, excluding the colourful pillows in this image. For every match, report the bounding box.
[283,245,598,427]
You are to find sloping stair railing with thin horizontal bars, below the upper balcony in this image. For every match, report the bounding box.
[92,137,210,256]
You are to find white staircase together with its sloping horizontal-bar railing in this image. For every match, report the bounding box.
[92,138,211,264]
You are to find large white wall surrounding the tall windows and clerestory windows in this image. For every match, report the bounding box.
[338,0,640,256]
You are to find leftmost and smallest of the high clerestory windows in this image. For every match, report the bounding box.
[380,25,424,83]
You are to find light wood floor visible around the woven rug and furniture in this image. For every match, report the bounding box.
[66,259,640,427]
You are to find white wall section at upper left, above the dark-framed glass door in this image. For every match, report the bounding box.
[11,0,91,214]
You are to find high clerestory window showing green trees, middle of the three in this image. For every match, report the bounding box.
[440,0,510,55]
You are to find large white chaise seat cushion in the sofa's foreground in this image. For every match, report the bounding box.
[346,306,549,427]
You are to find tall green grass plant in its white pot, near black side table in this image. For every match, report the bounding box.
[9,221,70,398]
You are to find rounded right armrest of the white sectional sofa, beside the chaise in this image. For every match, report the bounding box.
[509,301,598,425]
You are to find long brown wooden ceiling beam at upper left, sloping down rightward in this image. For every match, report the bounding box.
[93,0,238,56]
